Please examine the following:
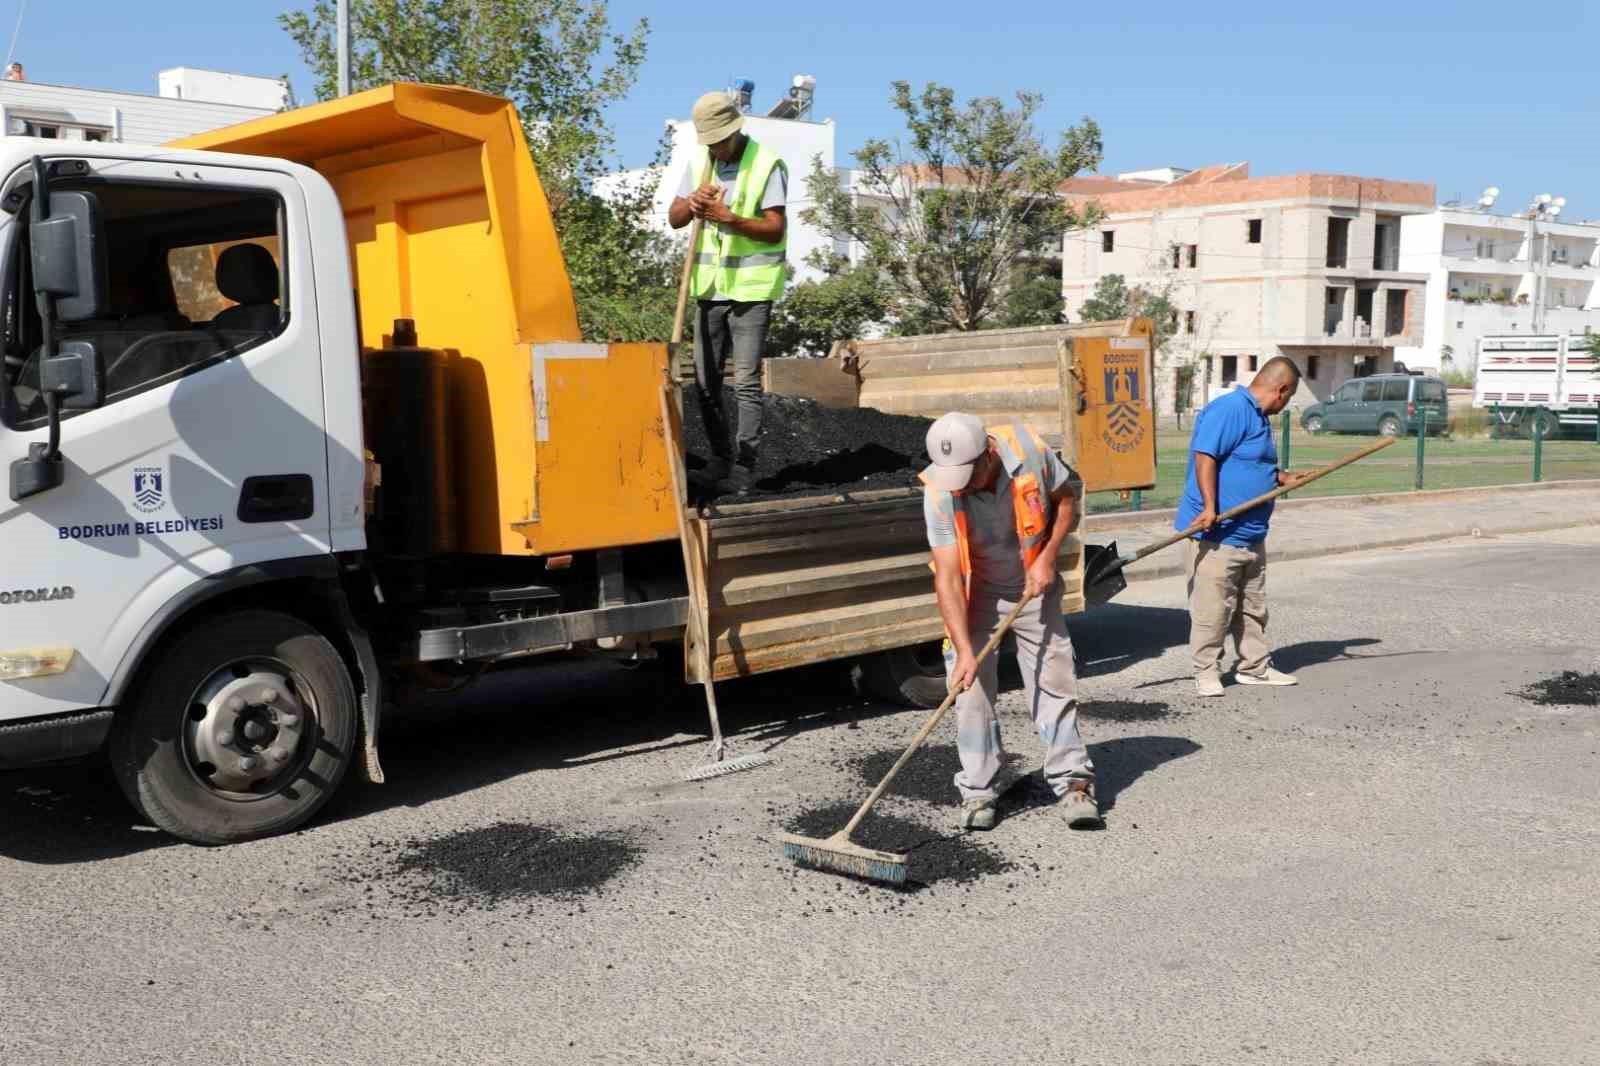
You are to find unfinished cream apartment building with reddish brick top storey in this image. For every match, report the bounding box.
[1062,163,1434,413]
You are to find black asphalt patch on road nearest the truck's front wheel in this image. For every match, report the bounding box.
[374,821,642,914]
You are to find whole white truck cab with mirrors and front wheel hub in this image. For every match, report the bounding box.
[0,138,365,839]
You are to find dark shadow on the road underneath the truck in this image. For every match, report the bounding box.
[0,661,921,864]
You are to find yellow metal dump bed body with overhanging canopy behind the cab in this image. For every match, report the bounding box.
[173,85,677,555]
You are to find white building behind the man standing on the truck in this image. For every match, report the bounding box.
[595,75,835,285]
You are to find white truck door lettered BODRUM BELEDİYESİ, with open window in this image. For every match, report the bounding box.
[0,158,330,719]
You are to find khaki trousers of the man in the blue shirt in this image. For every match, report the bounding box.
[1187,539,1272,675]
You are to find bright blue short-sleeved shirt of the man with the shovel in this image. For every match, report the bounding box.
[1173,387,1278,547]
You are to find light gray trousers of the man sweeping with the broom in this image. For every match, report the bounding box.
[944,579,1094,800]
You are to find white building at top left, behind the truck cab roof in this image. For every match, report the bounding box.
[0,67,288,144]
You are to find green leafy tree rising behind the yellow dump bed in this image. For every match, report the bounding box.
[278,0,677,339]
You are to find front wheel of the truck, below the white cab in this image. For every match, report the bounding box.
[110,610,358,844]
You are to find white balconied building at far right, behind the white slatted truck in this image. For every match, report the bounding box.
[1395,206,1600,370]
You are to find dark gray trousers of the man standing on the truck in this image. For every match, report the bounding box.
[694,299,773,459]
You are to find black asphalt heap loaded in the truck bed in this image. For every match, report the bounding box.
[683,387,933,503]
